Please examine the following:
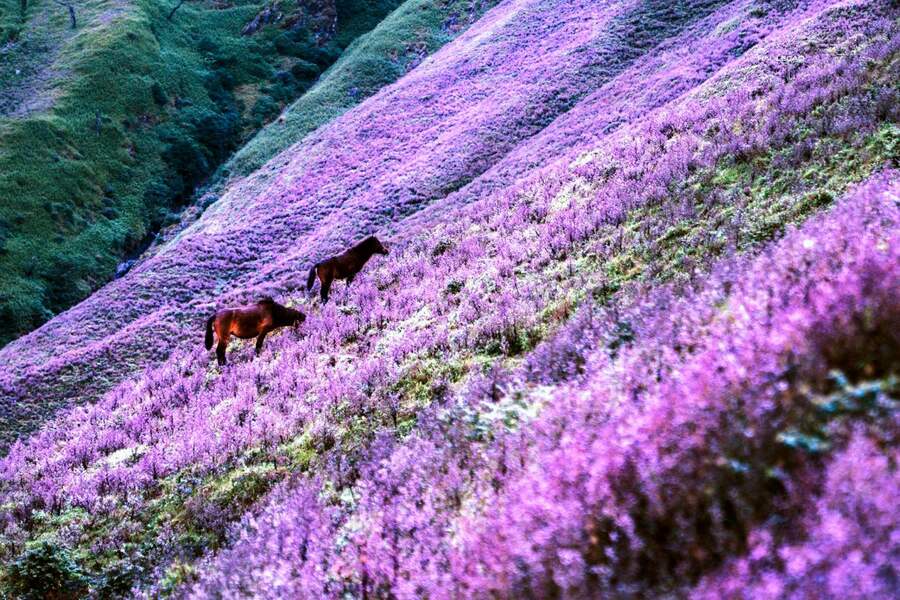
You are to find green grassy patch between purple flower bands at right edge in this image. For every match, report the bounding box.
[576,123,900,301]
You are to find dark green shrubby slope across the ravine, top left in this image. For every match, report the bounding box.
[0,0,400,344]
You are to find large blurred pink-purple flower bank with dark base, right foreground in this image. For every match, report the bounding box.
[455,176,900,596]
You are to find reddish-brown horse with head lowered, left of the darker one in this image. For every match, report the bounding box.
[206,298,306,365]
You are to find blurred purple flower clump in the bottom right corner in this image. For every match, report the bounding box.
[694,432,900,598]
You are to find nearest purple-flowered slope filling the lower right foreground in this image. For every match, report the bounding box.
[187,171,900,599]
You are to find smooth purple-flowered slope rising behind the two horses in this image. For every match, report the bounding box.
[0,2,744,448]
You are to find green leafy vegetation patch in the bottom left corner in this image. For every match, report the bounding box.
[0,434,318,599]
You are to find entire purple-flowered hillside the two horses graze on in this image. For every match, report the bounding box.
[0,0,900,598]
